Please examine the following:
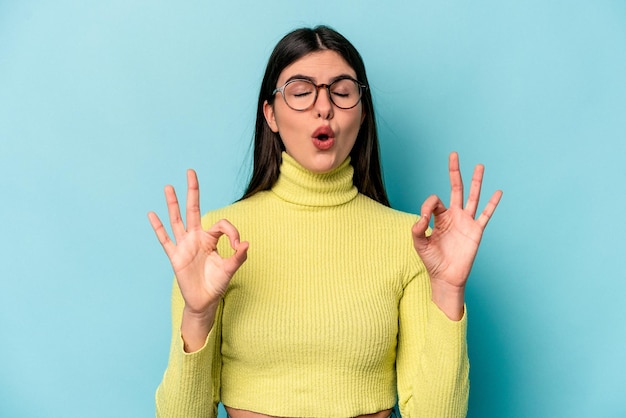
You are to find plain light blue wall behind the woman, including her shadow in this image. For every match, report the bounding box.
[0,0,626,418]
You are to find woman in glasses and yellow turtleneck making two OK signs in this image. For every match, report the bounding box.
[149,26,501,418]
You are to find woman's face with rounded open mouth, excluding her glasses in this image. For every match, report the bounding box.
[263,50,365,173]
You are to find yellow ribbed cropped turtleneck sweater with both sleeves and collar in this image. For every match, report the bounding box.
[156,154,469,418]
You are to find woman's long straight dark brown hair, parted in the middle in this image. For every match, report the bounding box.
[242,26,389,206]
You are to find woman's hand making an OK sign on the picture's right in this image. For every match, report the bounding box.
[412,152,502,319]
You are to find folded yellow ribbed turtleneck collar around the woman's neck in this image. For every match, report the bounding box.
[272,152,358,206]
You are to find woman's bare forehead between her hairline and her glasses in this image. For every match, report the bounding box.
[278,49,356,85]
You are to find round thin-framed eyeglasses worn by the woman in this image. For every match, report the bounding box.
[272,77,367,111]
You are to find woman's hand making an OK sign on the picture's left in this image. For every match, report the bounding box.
[148,170,248,316]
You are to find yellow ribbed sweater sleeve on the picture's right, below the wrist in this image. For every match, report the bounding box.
[396,258,469,418]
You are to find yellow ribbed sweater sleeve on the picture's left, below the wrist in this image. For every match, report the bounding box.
[156,280,222,418]
